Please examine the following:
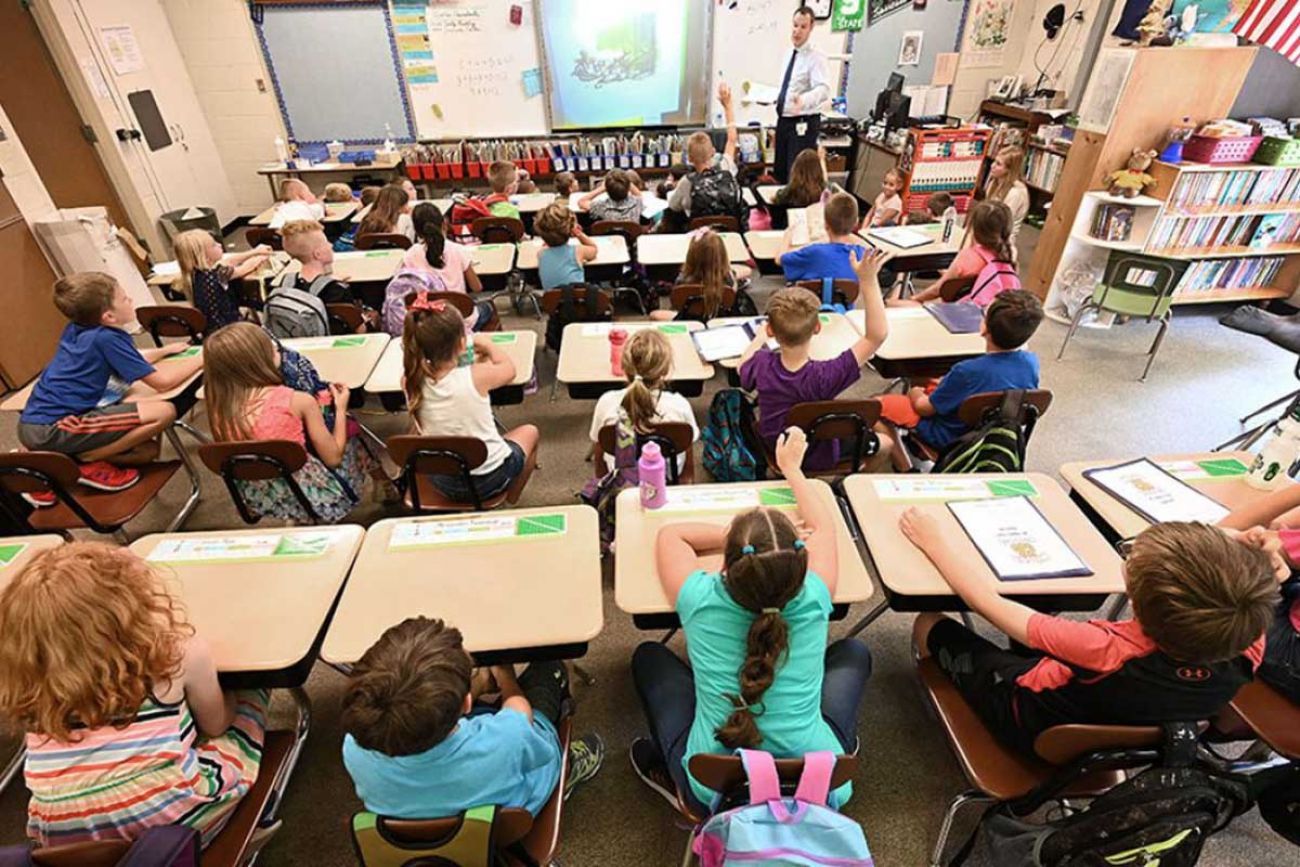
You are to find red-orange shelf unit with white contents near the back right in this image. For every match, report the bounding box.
[898,127,991,213]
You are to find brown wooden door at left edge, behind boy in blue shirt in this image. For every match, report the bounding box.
[0,183,68,389]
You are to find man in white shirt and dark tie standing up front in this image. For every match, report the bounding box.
[772,6,831,183]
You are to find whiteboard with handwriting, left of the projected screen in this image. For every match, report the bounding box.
[405,0,549,139]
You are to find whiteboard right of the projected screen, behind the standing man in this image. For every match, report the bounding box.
[709,0,848,126]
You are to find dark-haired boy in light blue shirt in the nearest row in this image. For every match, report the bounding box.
[343,617,605,819]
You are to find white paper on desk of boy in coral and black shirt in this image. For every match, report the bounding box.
[948,497,1092,581]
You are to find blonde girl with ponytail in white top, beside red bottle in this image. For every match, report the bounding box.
[590,328,699,472]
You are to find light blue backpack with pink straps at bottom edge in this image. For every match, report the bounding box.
[692,750,874,867]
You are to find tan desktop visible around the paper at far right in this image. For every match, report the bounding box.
[1061,451,1271,541]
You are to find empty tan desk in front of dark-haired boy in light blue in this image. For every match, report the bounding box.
[321,506,605,666]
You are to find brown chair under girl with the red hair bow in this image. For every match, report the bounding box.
[387,434,537,512]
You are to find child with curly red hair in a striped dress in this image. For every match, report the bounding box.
[0,542,269,846]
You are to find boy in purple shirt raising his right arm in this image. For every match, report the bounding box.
[740,251,889,469]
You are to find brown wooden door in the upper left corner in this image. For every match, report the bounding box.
[0,0,131,226]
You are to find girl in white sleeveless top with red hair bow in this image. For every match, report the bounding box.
[402,292,537,502]
